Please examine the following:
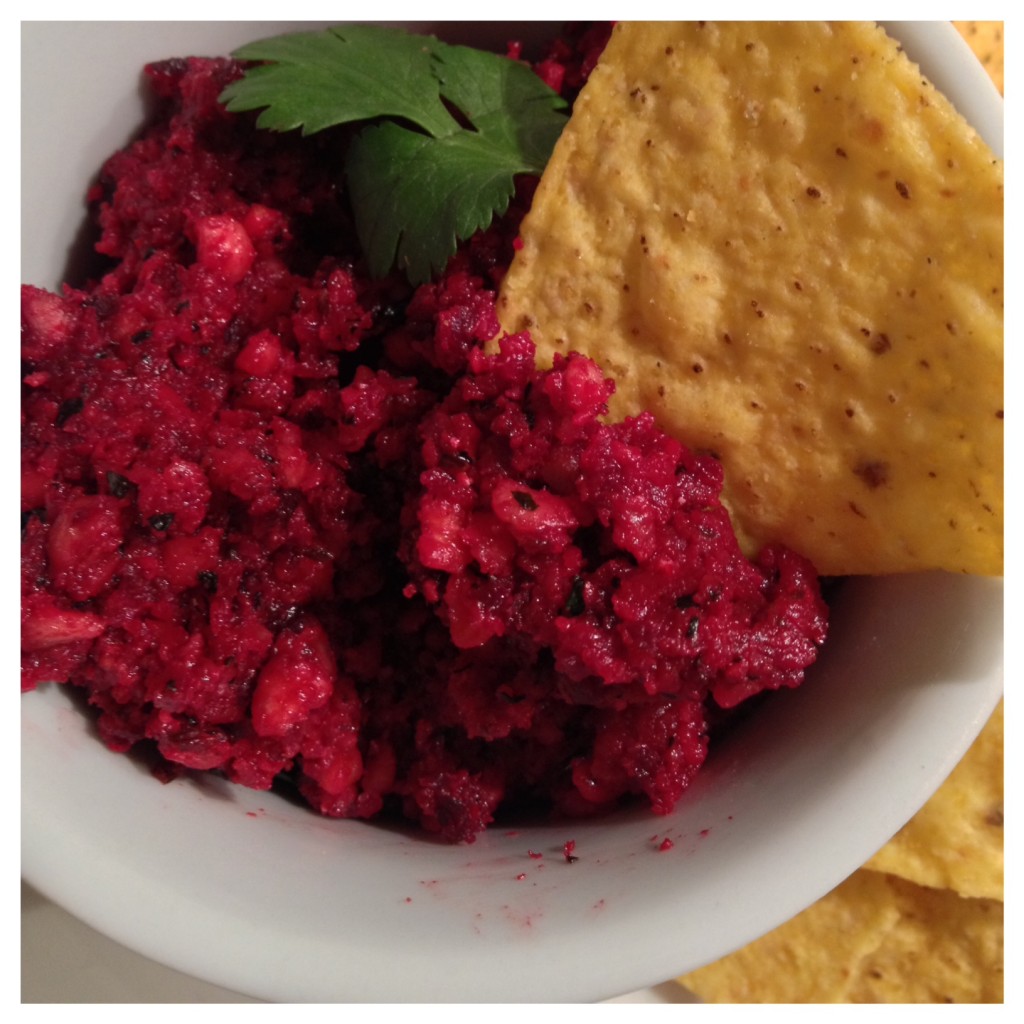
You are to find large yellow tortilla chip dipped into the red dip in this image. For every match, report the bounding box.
[499,22,1002,575]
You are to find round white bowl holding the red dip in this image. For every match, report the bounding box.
[22,23,1002,1002]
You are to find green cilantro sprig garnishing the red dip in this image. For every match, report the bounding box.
[220,25,566,284]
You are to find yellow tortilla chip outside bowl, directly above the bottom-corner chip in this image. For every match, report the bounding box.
[865,702,1002,900]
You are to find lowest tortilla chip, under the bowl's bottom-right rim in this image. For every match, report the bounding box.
[679,870,1004,1002]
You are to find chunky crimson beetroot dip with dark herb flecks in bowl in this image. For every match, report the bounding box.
[22,29,826,842]
